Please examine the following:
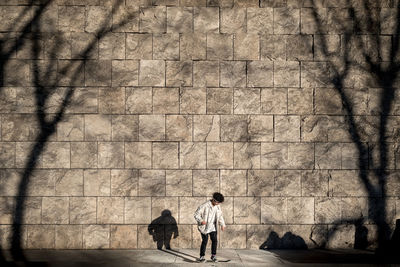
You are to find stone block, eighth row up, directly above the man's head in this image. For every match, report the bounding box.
[207,33,233,60]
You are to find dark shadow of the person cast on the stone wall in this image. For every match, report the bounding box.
[148,210,179,249]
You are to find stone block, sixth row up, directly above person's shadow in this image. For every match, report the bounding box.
[153,87,179,114]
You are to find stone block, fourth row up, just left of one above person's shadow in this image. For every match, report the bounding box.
[125,142,151,168]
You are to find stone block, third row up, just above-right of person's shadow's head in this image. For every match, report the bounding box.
[165,170,192,196]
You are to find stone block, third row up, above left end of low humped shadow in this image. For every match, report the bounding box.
[247,170,275,196]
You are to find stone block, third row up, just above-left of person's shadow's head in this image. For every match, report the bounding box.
[139,170,165,196]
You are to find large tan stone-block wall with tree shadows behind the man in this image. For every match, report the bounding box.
[0,0,400,249]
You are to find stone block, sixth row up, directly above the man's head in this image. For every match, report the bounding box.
[207,88,233,114]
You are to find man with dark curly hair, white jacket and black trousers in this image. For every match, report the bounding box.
[194,192,225,262]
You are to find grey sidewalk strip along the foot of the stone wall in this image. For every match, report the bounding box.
[0,249,399,267]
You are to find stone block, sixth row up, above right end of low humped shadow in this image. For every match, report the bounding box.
[287,88,314,115]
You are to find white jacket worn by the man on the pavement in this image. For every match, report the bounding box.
[194,200,225,234]
